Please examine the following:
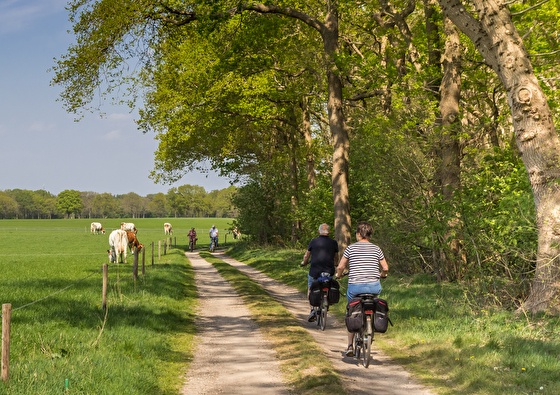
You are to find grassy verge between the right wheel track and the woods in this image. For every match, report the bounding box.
[228,245,560,395]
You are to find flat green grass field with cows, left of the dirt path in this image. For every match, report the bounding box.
[0,218,233,395]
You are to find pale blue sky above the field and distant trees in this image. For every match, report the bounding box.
[0,0,229,196]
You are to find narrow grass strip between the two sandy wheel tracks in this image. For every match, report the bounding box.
[200,252,345,395]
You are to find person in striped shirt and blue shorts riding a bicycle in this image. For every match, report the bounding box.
[336,222,389,357]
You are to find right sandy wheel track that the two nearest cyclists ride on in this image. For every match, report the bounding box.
[214,253,433,395]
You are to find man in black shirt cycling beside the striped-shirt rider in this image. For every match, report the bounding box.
[300,224,338,322]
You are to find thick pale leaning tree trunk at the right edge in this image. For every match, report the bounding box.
[439,0,560,314]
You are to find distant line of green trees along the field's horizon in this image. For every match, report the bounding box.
[0,185,237,219]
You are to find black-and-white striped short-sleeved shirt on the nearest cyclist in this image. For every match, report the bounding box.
[344,242,385,284]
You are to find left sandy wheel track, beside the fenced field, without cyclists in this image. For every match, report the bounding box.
[181,252,289,395]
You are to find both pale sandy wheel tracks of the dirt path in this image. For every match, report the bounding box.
[182,253,433,395]
